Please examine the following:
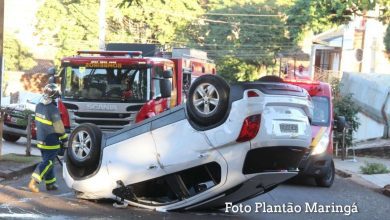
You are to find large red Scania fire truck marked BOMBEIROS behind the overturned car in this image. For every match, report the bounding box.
[54,48,215,131]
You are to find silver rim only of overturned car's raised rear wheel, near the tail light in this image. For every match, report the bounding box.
[192,83,219,115]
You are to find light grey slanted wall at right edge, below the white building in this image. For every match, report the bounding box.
[341,72,390,141]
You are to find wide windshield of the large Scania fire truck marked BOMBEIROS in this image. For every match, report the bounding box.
[61,66,150,102]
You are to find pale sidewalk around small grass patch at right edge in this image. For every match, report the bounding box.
[334,157,390,194]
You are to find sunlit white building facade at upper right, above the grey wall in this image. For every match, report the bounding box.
[309,11,390,81]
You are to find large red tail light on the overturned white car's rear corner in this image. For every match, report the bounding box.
[236,115,261,142]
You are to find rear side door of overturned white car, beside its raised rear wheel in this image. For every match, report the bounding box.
[151,109,221,173]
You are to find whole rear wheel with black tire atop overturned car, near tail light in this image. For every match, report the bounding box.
[187,75,230,127]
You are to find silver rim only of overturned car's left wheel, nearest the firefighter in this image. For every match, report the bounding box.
[72,131,92,160]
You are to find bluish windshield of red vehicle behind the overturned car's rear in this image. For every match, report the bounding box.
[312,96,330,126]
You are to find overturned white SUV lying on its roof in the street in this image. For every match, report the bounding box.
[63,75,312,210]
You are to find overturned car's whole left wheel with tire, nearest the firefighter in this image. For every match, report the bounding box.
[67,123,102,167]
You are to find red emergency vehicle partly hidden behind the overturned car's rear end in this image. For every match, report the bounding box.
[284,79,345,187]
